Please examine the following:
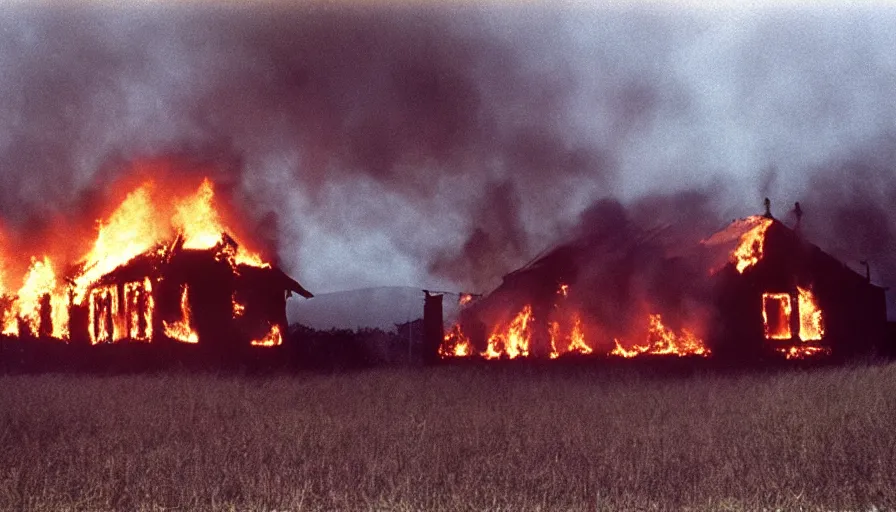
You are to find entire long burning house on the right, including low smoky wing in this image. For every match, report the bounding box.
[438,202,887,360]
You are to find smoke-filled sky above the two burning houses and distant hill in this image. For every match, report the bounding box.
[0,2,896,306]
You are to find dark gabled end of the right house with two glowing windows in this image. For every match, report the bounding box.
[705,206,887,358]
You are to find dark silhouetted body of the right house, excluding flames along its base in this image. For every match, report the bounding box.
[444,206,884,360]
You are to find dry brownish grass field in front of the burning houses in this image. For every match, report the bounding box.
[0,364,896,511]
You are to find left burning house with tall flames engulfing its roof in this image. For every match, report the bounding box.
[0,176,312,352]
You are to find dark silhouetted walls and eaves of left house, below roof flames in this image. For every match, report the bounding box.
[0,234,313,355]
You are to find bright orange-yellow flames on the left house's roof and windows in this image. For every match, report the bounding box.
[0,173,280,344]
